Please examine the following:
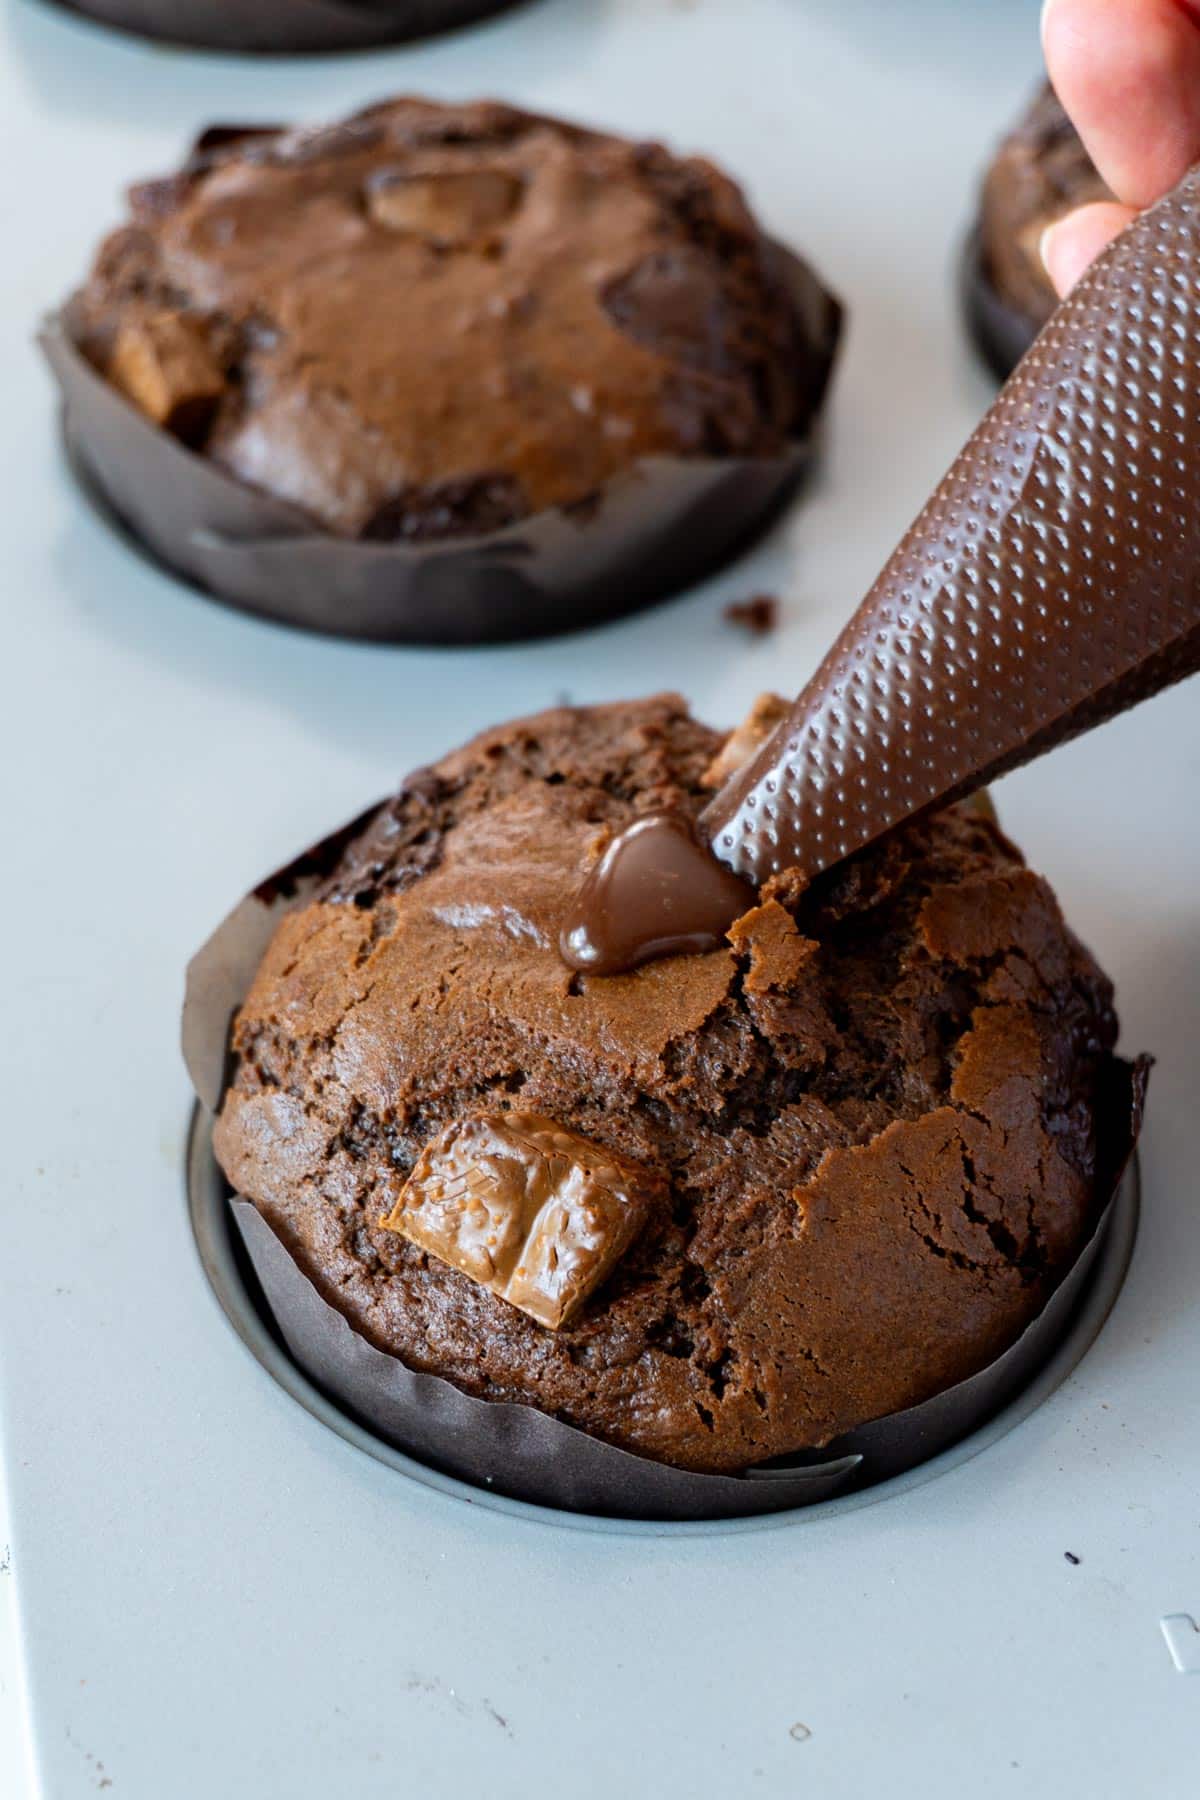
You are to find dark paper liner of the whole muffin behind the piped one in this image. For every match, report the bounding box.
[38,252,840,644]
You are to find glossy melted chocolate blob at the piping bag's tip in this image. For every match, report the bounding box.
[560,812,754,976]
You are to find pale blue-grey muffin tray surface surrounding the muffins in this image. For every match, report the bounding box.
[0,0,1200,1800]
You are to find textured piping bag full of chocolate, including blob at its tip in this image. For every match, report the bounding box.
[561,166,1200,974]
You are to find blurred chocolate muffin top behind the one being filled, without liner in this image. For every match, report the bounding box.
[67,99,837,540]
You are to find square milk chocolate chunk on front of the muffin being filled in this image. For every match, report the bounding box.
[380,1112,666,1332]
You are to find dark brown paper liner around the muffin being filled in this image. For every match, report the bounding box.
[184,812,1148,1521]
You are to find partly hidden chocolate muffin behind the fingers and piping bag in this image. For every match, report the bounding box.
[972,85,1112,374]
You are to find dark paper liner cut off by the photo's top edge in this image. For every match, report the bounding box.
[44,0,515,50]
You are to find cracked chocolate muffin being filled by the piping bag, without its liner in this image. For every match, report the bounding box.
[216,695,1115,1472]
